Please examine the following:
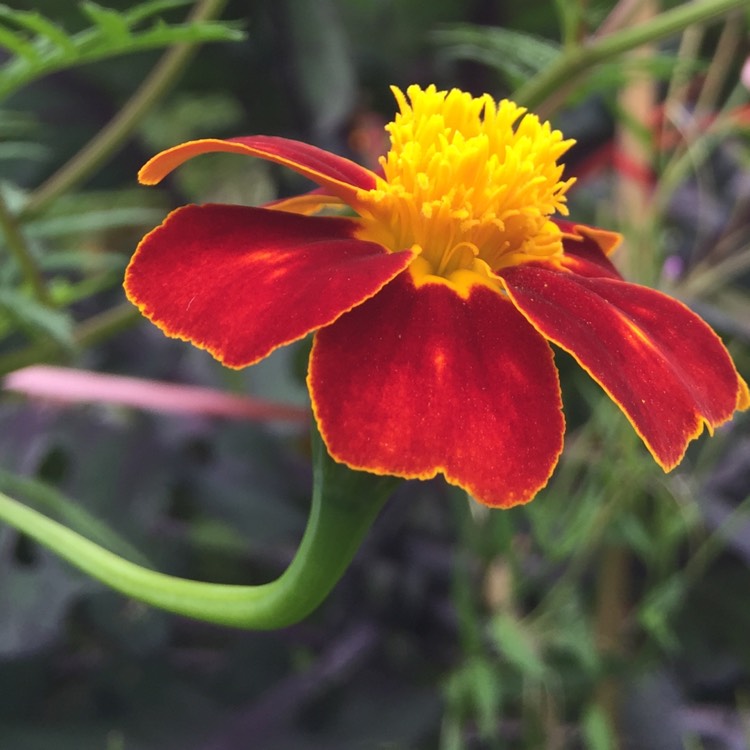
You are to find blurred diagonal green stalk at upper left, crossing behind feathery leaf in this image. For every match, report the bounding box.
[21,0,227,218]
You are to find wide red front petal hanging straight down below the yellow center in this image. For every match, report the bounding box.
[308,274,564,507]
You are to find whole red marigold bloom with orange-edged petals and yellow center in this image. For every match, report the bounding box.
[125,86,750,507]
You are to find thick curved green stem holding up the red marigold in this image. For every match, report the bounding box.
[0,438,397,629]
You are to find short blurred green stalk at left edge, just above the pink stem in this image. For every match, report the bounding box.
[0,303,143,376]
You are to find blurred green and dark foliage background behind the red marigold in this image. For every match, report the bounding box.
[0,0,750,750]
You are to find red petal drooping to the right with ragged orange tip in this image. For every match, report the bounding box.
[500,264,746,471]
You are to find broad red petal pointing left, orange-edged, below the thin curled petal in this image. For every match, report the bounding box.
[125,205,413,367]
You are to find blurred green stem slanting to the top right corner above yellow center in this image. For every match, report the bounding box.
[514,0,747,109]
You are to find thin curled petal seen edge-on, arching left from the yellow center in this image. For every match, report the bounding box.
[138,135,375,201]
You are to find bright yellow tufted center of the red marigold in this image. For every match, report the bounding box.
[357,86,573,295]
